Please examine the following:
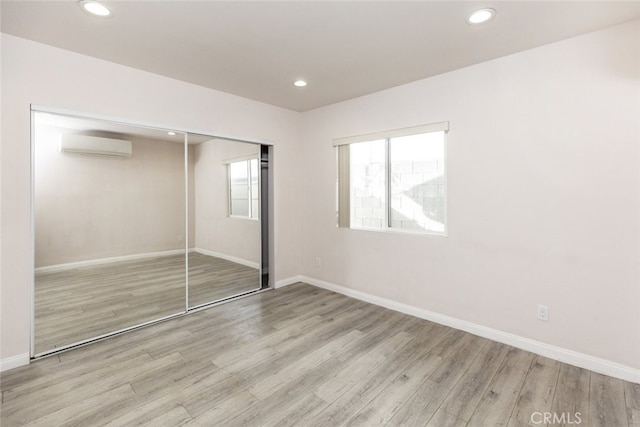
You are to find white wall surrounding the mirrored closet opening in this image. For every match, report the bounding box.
[0,34,301,361]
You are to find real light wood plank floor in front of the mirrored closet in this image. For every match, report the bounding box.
[0,284,640,427]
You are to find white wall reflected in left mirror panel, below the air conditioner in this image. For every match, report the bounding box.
[34,126,185,268]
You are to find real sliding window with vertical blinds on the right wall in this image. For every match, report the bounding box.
[334,122,449,234]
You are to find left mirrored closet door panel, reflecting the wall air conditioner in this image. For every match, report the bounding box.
[33,112,186,354]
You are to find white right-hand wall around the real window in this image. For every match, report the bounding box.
[302,22,640,372]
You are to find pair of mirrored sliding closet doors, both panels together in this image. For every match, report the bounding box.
[32,111,268,357]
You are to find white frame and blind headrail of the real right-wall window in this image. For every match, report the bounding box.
[333,122,449,237]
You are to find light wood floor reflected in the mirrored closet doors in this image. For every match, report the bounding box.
[35,252,260,354]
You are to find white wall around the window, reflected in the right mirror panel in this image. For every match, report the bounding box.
[193,139,260,265]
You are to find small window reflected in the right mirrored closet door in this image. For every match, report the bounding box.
[228,159,259,219]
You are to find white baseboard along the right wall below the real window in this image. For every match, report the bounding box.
[298,276,640,384]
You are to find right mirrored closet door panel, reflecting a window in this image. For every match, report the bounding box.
[188,138,261,308]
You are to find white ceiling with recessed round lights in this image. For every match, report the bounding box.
[0,0,640,111]
